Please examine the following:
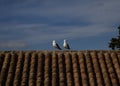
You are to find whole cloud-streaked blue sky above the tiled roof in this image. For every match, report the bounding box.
[0,0,120,50]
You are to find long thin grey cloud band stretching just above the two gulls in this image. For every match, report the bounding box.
[0,24,112,43]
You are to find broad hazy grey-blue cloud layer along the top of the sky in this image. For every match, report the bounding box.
[3,0,120,25]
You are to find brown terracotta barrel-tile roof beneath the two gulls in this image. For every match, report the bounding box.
[0,51,120,86]
